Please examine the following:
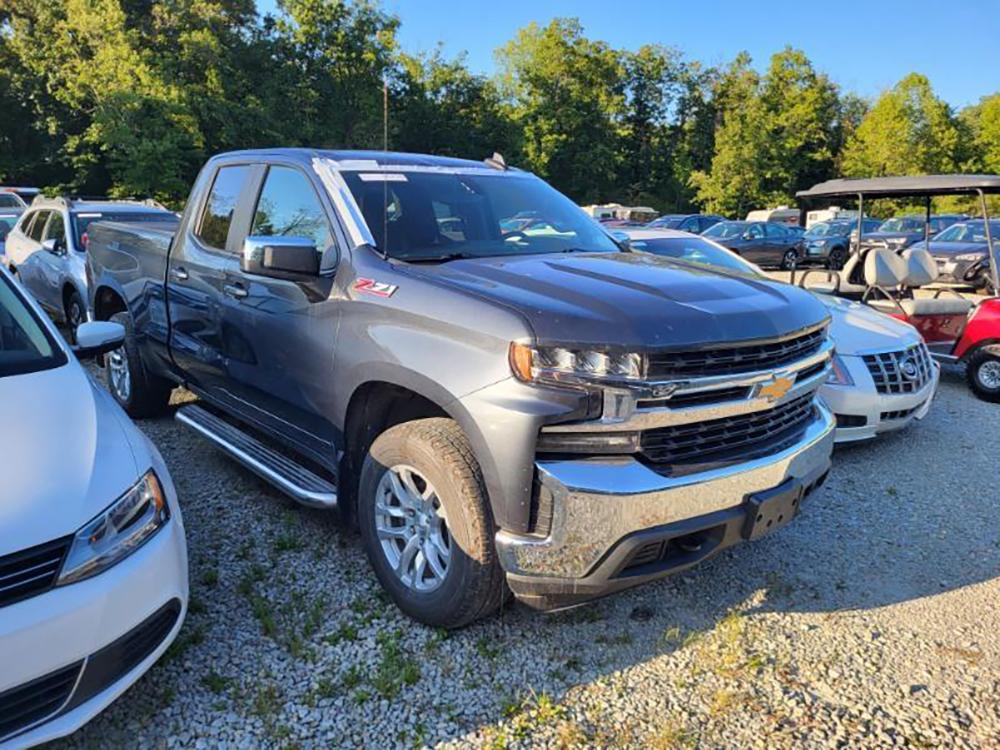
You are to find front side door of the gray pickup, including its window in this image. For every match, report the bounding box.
[222,163,339,460]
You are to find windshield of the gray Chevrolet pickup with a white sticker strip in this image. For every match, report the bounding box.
[343,169,620,262]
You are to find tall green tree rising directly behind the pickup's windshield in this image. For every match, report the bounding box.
[497,19,624,203]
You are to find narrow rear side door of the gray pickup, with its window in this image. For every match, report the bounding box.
[167,162,259,402]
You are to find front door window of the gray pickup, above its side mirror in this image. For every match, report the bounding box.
[250,167,333,252]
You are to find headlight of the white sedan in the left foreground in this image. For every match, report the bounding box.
[56,469,170,586]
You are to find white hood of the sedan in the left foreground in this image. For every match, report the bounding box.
[0,359,149,556]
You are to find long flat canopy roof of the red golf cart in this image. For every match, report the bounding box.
[795,174,1000,202]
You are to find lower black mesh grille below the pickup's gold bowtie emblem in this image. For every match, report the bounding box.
[641,393,815,466]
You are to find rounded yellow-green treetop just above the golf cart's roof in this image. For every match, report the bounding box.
[842,73,967,177]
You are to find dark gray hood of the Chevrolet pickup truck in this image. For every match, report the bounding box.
[406,253,827,350]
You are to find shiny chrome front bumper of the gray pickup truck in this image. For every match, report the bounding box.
[496,404,835,608]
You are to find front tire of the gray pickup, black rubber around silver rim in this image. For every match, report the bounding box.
[358,418,507,628]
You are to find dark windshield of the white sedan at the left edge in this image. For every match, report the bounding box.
[0,275,66,378]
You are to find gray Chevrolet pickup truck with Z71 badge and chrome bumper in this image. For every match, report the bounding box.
[88,149,834,627]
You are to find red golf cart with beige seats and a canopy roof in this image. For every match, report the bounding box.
[792,175,1000,402]
